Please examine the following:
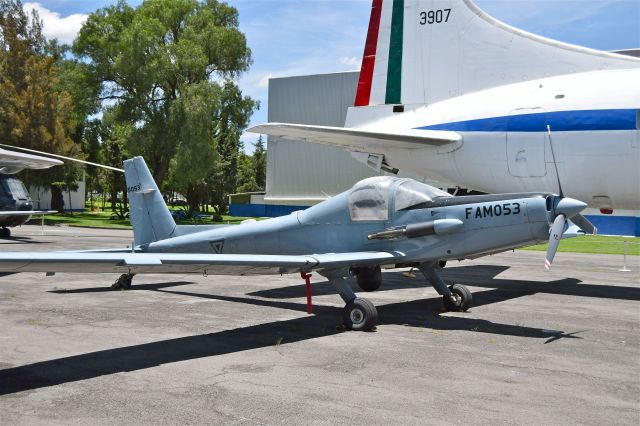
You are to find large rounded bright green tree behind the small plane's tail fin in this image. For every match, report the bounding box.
[73,0,256,191]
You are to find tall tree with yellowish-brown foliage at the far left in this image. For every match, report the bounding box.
[0,0,80,211]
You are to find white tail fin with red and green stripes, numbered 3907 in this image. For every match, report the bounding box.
[355,0,640,109]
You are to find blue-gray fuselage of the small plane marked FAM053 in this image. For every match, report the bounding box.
[144,188,553,262]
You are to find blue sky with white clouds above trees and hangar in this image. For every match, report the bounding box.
[25,0,640,152]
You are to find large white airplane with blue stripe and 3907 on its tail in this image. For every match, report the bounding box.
[249,0,640,213]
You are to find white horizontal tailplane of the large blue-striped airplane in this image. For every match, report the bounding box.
[248,123,462,151]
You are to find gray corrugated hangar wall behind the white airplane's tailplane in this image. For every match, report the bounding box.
[265,71,388,206]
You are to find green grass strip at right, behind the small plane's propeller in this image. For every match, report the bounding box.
[522,235,640,256]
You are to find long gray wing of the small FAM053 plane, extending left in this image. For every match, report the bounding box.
[0,252,404,275]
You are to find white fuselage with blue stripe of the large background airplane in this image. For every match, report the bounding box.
[346,70,640,210]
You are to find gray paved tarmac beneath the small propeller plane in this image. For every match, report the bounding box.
[0,226,640,425]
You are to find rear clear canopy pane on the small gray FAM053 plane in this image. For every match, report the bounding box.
[349,176,393,220]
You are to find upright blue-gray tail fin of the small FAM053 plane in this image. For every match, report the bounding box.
[124,157,176,246]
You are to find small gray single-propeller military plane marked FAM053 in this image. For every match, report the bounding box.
[0,157,593,330]
